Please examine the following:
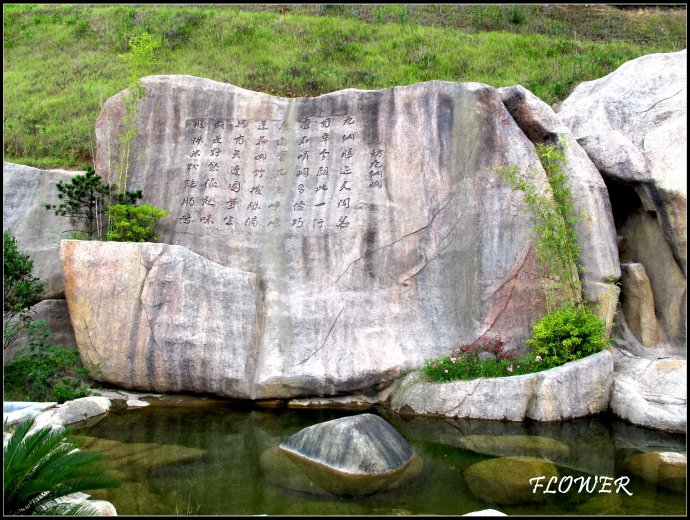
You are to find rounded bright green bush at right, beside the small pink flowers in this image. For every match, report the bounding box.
[526,306,609,368]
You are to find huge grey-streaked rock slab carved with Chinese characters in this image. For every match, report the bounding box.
[91,76,584,399]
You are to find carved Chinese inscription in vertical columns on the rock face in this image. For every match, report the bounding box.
[177,114,385,235]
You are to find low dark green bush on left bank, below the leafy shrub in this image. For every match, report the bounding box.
[3,321,93,403]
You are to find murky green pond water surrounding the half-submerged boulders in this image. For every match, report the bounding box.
[73,404,686,515]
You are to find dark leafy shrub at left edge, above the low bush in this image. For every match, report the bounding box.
[2,229,45,350]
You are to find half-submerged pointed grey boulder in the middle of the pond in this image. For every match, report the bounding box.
[260,414,422,496]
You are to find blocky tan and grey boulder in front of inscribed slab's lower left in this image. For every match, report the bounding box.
[60,240,260,398]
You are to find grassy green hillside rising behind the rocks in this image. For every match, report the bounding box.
[3,4,686,167]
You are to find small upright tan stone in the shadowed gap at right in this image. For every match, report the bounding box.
[621,264,659,347]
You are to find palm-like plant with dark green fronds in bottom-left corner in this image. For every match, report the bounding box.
[3,417,120,515]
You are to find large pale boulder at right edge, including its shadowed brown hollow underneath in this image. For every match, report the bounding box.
[558,50,687,350]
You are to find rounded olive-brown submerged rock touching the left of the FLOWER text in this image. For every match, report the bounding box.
[465,457,559,506]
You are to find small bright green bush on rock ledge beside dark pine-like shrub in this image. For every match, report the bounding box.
[107,202,168,242]
